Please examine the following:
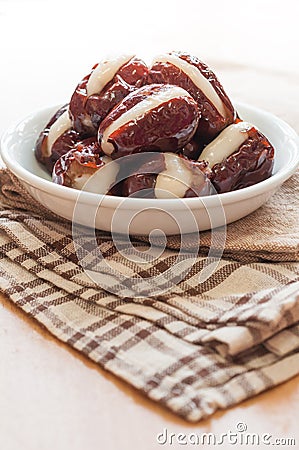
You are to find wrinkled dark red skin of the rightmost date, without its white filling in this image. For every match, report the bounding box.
[211,128,274,194]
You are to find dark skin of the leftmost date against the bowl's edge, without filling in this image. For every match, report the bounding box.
[35,105,81,173]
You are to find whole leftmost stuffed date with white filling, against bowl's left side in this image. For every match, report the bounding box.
[35,105,82,173]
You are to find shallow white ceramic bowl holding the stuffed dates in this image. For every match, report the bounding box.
[1,104,299,235]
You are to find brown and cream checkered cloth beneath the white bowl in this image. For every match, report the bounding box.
[0,171,299,421]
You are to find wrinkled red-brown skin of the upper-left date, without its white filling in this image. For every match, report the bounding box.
[70,58,148,136]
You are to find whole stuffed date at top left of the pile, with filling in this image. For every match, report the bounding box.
[70,55,148,135]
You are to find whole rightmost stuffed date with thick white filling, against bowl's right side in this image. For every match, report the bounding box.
[199,121,274,193]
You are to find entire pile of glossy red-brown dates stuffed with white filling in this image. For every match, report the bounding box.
[35,52,274,198]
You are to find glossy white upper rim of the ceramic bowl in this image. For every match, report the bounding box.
[0,102,299,210]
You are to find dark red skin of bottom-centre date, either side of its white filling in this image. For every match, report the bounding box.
[122,153,214,198]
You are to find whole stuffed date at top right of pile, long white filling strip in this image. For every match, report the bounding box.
[148,52,236,143]
